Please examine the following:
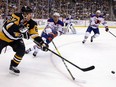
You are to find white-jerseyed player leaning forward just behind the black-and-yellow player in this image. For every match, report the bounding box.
[26,12,64,56]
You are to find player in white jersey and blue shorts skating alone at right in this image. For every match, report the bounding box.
[82,10,109,44]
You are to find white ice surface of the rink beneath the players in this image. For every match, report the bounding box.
[0,28,116,87]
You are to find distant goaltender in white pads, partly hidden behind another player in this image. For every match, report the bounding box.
[65,15,76,34]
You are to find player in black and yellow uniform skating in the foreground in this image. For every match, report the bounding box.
[0,6,48,75]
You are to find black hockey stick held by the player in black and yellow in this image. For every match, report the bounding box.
[34,41,95,72]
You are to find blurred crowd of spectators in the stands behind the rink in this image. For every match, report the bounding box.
[0,0,116,20]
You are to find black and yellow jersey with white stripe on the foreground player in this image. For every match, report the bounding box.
[0,13,38,42]
